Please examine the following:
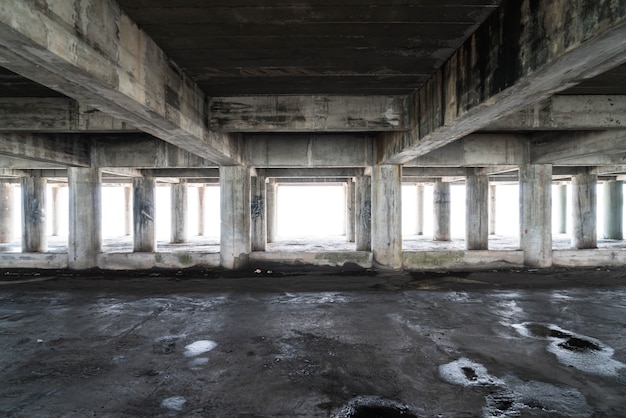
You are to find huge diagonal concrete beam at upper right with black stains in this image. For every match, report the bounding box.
[377,0,626,164]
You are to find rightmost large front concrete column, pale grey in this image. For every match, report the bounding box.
[519,164,552,267]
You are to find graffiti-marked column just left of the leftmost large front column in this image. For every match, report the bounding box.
[22,175,48,253]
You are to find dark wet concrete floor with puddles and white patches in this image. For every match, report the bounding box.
[0,266,626,417]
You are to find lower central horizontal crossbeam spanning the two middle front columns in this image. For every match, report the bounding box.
[245,134,373,168]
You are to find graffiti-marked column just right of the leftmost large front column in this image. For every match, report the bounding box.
[133,177,156,253]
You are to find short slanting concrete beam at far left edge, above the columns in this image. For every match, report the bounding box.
[0,133,91,167]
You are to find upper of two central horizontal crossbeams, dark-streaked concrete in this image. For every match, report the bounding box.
[210,96,412,132]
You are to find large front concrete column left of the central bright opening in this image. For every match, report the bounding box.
[220,166,251,269]
